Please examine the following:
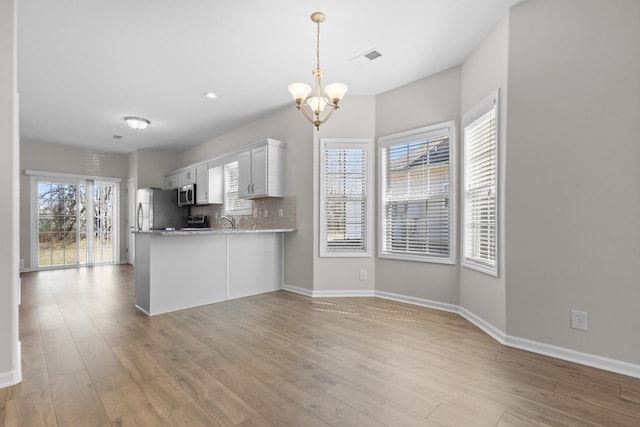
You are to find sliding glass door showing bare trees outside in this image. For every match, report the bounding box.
[35,178,117,269]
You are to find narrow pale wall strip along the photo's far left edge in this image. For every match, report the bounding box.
[0,0,21,386]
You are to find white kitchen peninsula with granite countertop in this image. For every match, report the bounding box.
[135,229,294,316]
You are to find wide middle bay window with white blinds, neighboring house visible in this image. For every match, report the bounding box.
[380,122,455,264]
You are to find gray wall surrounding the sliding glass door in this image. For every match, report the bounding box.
[20,144,128,268]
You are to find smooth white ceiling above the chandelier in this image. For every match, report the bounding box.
[18,0,522,153]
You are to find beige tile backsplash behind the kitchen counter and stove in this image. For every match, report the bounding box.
[191,196,296,230]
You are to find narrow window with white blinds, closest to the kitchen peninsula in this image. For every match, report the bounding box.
[320,138,371,257]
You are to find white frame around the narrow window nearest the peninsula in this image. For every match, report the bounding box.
[318,138,373,258]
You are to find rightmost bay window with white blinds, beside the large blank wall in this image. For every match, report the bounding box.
[462,91,499,276]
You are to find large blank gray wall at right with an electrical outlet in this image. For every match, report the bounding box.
[505,0,640,364]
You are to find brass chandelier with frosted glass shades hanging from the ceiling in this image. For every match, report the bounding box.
[289,12,349,130]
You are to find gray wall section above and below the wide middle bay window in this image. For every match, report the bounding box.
[375,67,461,305]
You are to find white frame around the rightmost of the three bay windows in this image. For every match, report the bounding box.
[460,89,501,277]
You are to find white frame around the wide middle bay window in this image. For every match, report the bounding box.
[377,120,458,265]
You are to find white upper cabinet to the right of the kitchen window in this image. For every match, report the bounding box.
[238,139,285,199]
